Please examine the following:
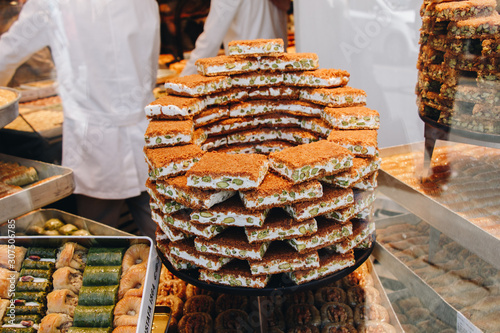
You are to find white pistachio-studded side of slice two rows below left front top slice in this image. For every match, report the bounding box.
[191,209,269,227]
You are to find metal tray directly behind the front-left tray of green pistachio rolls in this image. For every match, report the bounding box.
[0,208,133,237]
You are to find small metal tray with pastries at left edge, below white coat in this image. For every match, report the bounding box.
[0,154,74,222]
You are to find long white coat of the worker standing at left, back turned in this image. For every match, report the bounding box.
[0,0,160,199]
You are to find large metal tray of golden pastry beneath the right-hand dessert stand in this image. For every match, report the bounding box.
[379,141,500,269]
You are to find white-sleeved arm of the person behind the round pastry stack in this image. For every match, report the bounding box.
[181,0,242,76]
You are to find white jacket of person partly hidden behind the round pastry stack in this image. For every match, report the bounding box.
[181,0,288,76]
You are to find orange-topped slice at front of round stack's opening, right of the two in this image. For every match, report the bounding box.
[269,140,353,183]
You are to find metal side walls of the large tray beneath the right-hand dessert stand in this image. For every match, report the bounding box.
[378,142,500,269]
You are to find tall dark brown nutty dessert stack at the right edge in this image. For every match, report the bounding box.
[416,0,500,134]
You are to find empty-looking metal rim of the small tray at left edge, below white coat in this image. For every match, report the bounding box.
[0,154,75,222]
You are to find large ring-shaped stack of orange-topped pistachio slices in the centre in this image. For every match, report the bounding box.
[145,39,380,288]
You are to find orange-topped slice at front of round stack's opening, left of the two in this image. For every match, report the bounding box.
[186,152,269,191]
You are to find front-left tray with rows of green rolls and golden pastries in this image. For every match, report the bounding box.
[0,233,161,333]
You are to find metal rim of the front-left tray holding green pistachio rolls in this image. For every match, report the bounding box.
[0,235,161,333]
